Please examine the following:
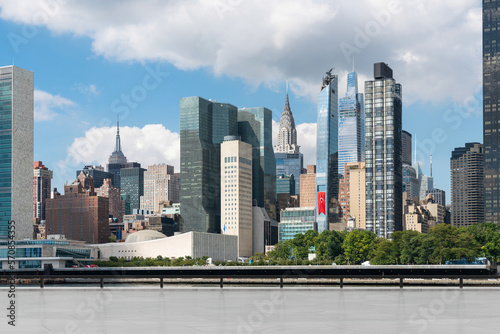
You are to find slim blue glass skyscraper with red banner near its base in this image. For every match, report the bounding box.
[316,70,339,233]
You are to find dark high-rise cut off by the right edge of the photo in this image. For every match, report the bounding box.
[483,0,500,224]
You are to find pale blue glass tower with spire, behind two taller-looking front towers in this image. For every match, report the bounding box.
[338,72,365,175]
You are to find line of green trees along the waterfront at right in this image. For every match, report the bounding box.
[253,223,500,265]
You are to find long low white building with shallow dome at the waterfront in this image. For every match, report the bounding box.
[99,230,238,261]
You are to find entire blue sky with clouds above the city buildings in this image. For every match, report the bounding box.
[0,0,482,203]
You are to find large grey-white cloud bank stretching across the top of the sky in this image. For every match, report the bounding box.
[0,0,482,103]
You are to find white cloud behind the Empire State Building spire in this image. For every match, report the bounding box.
[59,124,180,175]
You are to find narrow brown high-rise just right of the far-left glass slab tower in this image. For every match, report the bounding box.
[33,161,53,220]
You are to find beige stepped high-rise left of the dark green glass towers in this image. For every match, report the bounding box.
[141,164,179,213]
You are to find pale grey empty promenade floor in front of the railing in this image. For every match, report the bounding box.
[0,286,500,334]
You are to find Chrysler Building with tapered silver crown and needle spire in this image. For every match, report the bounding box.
[274,87,304,194]
